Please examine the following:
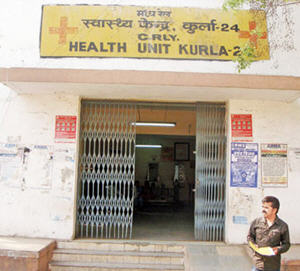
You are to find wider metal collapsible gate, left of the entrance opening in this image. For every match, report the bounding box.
[76,101,136,238]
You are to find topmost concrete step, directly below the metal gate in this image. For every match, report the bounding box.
[57,241,184,255]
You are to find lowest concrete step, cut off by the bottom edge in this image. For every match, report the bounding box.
[50,261,184,271]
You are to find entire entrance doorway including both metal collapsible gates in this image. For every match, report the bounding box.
[76,101,225,241]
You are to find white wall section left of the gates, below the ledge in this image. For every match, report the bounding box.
[0,85,79,239]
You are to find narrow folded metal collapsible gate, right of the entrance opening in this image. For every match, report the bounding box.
[195,104,226,241]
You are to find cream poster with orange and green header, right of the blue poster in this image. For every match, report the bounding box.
[261,144,288,187]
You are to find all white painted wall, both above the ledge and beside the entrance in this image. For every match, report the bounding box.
[0,0,300,243]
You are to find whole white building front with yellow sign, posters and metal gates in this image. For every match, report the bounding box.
[0,0,300,244]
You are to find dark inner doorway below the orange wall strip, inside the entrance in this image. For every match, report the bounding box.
[132,134,195,241]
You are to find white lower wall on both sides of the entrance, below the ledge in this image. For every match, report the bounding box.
[0,90,300,244]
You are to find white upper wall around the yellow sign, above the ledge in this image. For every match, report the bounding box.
[0,0,300,76]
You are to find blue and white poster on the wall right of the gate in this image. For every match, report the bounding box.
[230,142,258,187]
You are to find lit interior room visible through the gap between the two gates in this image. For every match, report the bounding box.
[132,104,196,240]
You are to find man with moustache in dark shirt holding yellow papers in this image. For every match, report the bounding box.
[247,196,290,271]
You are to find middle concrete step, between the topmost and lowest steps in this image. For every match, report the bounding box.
[52,249,184,264]
